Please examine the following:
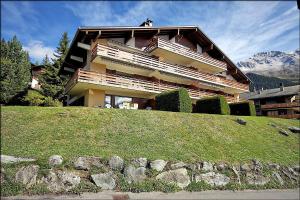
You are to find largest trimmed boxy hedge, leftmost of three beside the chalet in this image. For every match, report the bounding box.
[155,88,193,113]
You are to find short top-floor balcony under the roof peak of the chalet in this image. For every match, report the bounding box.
[144,38,227,73]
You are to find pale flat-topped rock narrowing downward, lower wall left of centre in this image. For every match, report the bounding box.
[91,172,116,190]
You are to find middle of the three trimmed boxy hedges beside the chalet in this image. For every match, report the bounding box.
[195,95,230,115]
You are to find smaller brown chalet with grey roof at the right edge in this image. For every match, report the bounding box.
[241,84,300,119]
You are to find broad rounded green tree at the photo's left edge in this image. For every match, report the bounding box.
[0,36,31,104]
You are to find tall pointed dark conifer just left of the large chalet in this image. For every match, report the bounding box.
[39,32,69,99]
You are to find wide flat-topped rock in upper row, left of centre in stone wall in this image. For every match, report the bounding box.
[74,157,103,170]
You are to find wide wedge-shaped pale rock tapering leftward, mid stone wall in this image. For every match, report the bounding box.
[156,168,191,188]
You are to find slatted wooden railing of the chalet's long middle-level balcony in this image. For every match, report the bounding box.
[92,44,248,91]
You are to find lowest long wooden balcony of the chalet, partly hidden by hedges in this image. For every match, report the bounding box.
[65,69,236,102]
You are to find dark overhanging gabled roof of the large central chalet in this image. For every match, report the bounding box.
[61,25,251,83]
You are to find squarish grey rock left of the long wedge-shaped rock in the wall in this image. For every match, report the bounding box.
[124,165,147,183]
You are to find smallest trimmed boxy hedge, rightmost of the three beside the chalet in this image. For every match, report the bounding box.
[229,101,256,116]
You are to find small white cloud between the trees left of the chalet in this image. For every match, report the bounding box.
[23,40,55,62]
